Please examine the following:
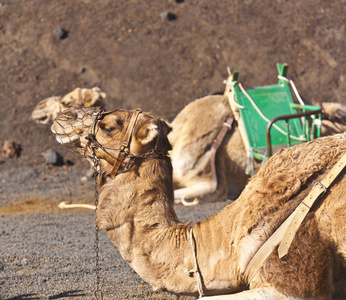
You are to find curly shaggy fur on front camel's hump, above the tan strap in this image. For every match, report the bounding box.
[251,133,346,201]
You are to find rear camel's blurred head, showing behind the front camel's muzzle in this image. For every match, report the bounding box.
[31,87,106,124]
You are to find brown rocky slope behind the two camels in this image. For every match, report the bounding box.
[0,0,346,176]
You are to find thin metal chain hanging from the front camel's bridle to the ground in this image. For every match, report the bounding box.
[92,147,103,300]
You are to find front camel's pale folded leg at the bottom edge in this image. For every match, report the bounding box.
[200,288,301,300]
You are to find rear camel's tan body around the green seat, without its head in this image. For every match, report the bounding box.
[169,95,346,203]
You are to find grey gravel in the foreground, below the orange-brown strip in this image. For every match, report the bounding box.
[0,192,230,300]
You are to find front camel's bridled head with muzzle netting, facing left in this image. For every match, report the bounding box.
[51,107,171,176]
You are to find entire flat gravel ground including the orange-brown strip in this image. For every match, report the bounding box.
[0,155,228,300]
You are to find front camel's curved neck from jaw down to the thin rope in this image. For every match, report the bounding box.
[98,164,197,294]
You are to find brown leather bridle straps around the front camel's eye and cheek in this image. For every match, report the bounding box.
[85,108,167,179]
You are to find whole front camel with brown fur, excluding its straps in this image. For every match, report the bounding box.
[52,108,346,300]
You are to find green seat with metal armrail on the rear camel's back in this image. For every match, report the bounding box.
[225,64,321,173]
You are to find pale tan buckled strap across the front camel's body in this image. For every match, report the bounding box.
[244,153,346,283]
